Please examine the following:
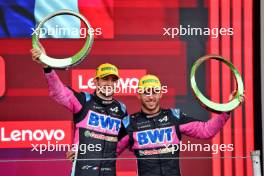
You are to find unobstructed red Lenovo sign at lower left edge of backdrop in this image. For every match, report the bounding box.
[0,121,72,148]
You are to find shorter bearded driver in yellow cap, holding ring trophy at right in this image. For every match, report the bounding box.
[118,75,244,176]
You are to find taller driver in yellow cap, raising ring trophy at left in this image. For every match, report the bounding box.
[31,47,127,176]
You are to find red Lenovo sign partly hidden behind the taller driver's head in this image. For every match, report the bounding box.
[72,69,147,95]
